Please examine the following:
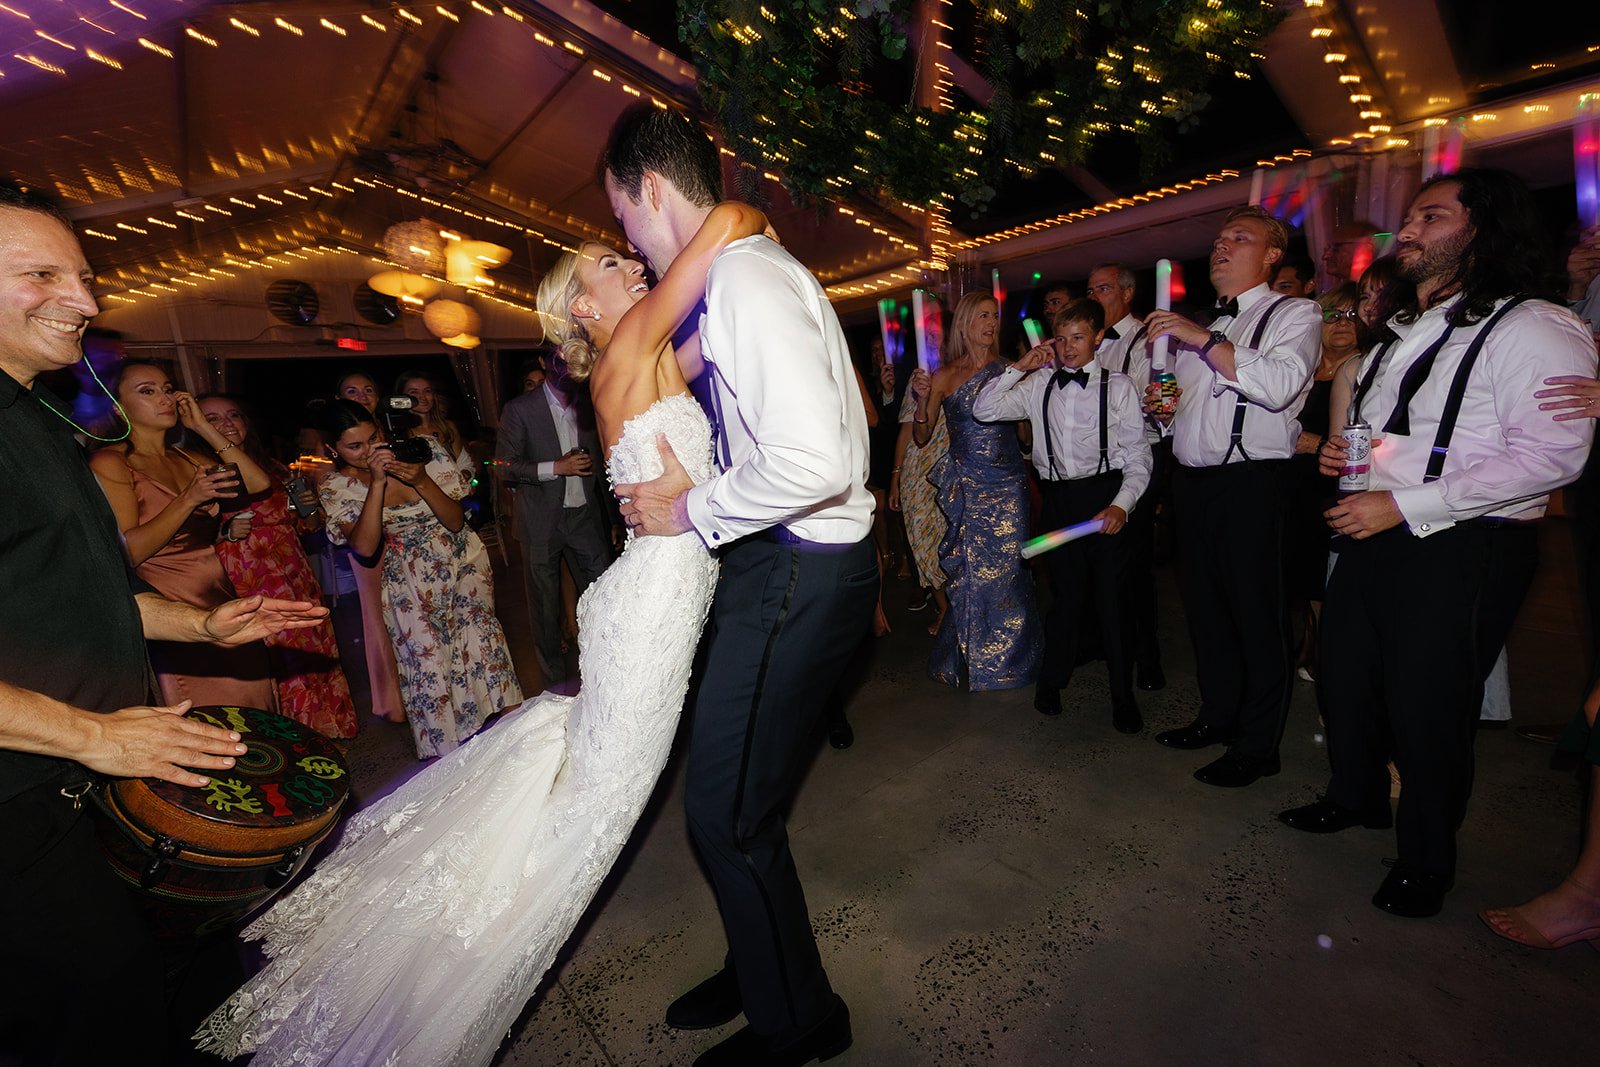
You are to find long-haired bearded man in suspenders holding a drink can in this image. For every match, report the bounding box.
[1282,170,1595,918]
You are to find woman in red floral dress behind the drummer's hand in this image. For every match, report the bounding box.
[200,394,357,739]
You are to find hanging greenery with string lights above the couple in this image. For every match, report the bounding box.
[678,0,1282,211]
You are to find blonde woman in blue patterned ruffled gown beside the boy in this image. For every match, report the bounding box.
[912,293,1043,691]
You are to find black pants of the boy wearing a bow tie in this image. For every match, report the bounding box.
[1038,470,1133,702]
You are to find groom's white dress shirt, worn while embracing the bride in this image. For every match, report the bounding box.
[688,237,872,547]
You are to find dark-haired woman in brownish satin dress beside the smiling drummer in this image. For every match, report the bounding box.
[90,360,275,710]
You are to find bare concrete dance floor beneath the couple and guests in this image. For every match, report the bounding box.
[331,520,1600,1067]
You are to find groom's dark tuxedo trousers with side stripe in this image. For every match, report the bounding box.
[683,528,878,1033]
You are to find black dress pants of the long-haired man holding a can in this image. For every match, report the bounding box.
[1318,520,1539,878]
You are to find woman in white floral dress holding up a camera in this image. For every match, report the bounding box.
[322,400,522,760]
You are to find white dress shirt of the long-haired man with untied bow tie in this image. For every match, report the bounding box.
[1362,301,1595,537]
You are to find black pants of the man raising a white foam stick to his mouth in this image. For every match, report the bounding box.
[1173,459,1291,758]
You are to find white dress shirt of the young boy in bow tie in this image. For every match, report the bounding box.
[973,362,1154,515]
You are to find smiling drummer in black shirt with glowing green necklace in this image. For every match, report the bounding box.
[0,181,326,1064]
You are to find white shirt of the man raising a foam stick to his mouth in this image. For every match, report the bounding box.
[1168,282,1322,467]
